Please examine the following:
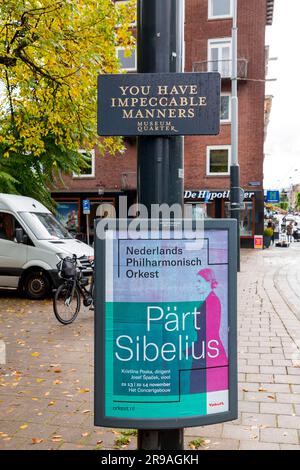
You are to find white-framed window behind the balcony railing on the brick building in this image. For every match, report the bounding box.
[208,38,231,78]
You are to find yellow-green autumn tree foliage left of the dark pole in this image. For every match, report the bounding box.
[0,0,136,205]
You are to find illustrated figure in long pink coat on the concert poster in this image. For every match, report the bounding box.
[190,269,228,393]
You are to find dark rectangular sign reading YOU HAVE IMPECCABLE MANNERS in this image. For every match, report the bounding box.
[98,72,221,136]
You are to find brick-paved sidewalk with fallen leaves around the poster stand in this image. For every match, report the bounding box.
[0,243,300,450]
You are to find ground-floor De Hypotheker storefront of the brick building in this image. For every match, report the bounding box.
[184,189,264,248]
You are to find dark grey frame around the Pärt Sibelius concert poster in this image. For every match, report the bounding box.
[94,219,238,430]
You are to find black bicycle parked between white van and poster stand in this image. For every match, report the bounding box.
[53,255,94,325]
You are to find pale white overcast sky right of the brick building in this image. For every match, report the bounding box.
[264,0,300,189]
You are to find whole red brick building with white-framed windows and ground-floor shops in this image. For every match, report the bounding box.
[53,0,274,246]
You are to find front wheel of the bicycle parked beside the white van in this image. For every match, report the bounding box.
[53,283,80,325]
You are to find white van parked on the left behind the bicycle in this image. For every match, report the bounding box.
[0,194,94,299]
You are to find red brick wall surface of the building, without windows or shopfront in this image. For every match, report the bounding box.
[54,0,266,195]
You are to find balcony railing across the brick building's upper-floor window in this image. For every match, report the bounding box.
[193,59,248,80]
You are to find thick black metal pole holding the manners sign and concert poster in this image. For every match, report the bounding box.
[137,0,184,450]
